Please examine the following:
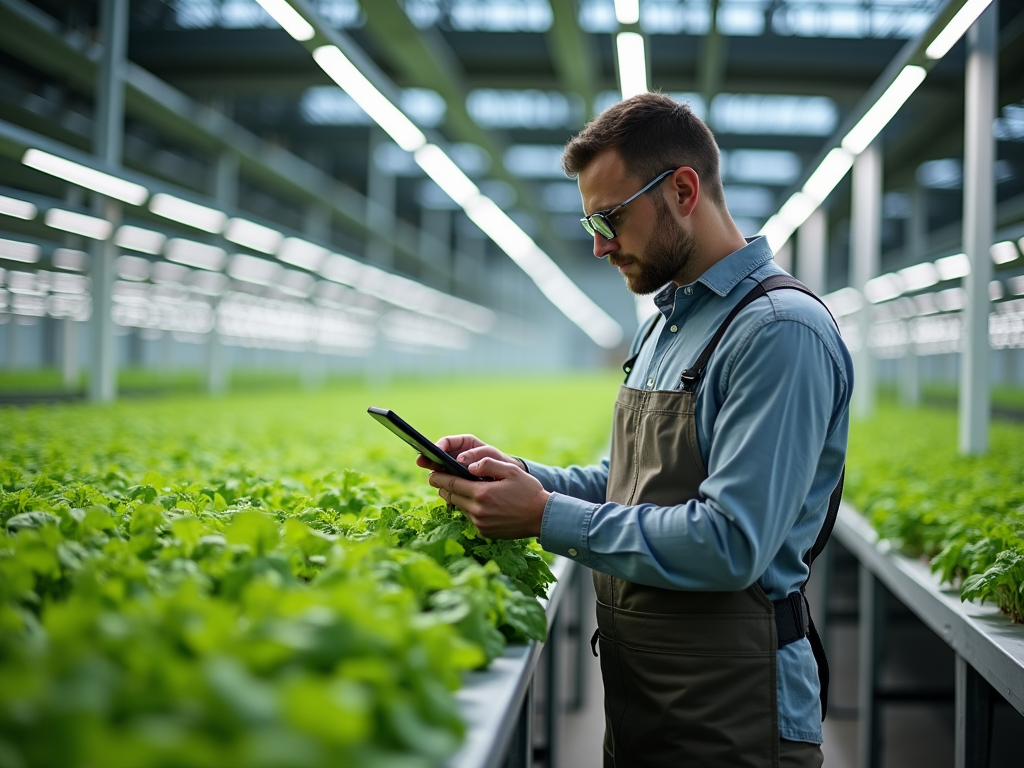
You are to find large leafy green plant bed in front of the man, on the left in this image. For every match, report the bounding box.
[0,377,615,768]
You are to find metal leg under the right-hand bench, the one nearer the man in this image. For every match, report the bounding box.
[857,565,885,768]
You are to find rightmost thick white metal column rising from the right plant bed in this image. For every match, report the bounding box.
[959,2,999,456]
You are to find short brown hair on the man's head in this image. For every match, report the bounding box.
[562,93,725,208]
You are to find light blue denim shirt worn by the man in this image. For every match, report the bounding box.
[528,238,853,743]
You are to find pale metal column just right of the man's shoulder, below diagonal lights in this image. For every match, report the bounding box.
[850,142,882,419]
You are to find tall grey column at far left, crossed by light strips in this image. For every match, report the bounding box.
[88,0,128,402]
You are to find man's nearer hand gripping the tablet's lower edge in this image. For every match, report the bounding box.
[420,456,551,539]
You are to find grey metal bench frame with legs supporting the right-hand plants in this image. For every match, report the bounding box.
[833,504,1024,768]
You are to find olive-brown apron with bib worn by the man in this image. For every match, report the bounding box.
[594,386,779,768]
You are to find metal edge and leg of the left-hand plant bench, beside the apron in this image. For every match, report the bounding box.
[447,557,589,768]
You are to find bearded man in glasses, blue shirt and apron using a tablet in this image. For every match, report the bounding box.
[421,93,853,768]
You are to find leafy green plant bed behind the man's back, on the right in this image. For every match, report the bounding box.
[846,406,1024,623]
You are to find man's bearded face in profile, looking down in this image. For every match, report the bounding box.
[580,151,693,296]
